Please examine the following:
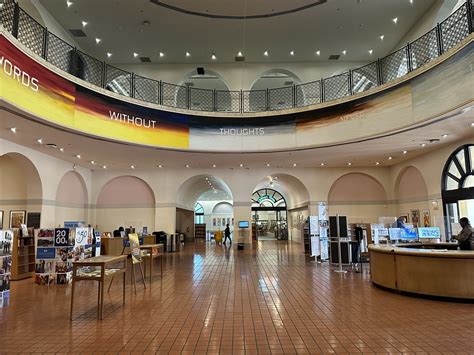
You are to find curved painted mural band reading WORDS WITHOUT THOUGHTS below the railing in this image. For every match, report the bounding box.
[0,30,474,151]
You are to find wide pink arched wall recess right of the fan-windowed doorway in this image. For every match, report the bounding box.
[328,173,386,223]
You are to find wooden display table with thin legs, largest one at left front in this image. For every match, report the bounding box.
[70,255,127,320]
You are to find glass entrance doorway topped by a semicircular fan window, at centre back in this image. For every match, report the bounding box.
[252,189,288,240]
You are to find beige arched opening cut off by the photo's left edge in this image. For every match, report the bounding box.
[0,153,43,229]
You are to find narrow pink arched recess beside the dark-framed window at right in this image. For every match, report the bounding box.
[395,166,433,227]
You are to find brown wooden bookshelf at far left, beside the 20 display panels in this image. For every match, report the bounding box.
[11,229,36,280]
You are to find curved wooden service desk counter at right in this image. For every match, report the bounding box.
[369,245,474,299]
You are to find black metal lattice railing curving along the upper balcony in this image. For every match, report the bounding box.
[0,0,474,113]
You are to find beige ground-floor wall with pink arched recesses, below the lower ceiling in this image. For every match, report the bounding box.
[0,139,472,241]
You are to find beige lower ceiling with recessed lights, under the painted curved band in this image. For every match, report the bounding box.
[0,106,474,171]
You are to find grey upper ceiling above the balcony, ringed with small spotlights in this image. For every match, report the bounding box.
[39,0,436,64]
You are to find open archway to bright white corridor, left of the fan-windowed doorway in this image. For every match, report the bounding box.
[176,175,234,241]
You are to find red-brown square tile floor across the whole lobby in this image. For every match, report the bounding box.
[0,241,474,354]
